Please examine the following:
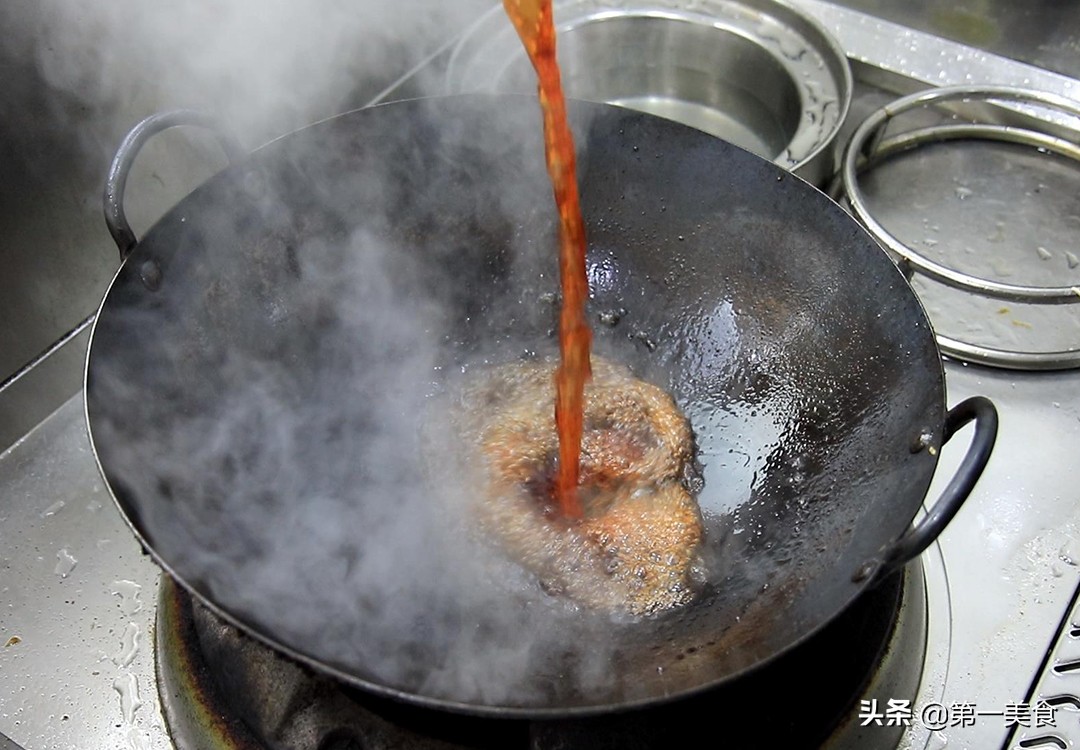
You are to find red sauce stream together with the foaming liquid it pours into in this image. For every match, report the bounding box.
[442,0,702,615]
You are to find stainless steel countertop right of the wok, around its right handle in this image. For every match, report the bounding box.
[918,363,1080,750]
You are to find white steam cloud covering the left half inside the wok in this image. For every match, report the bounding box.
[93,140,626,706]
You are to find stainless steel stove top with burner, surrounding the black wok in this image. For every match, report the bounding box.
[0,0,1080,750]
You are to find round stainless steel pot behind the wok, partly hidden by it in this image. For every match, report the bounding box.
[447,0,852,185]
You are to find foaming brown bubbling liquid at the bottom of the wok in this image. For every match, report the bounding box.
[459,359,702,615]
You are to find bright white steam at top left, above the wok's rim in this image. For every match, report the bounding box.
[25,0,491,139]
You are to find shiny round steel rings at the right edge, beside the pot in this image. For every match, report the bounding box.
[832,85,1080,370]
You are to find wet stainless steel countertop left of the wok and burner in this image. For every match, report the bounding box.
[0,392,172,750]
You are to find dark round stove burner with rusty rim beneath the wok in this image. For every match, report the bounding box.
[157,564,926,750]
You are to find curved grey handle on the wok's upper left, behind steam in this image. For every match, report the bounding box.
[105,109,247,260]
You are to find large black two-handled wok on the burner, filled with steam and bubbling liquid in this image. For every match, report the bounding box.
[85,95,997,716]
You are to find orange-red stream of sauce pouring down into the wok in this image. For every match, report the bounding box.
[502,0,592,519]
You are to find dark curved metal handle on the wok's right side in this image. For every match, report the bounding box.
[854,396,998,581]
